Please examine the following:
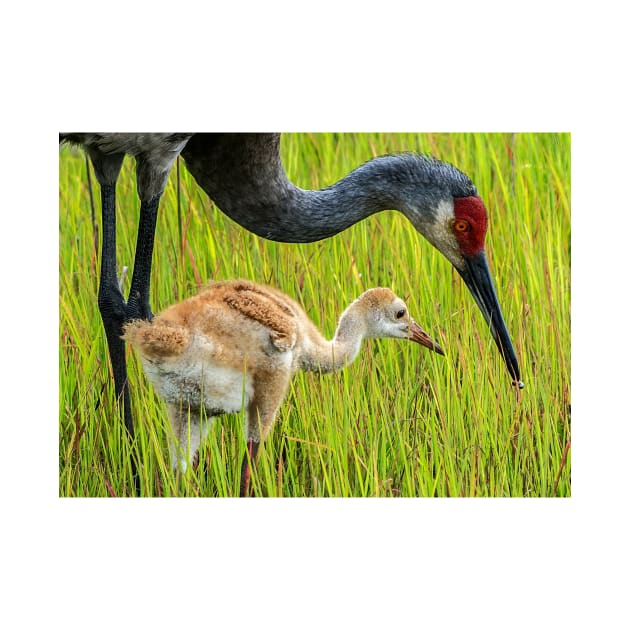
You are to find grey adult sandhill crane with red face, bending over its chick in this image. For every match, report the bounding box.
[60,133,522,456]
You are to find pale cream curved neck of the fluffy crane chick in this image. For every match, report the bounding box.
[299,305,366,372]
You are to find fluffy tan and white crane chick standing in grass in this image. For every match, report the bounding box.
[124,280,444,496]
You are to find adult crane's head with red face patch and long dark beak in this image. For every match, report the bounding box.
[403,156,524,388]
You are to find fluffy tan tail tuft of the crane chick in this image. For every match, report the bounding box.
[122,318,190,358]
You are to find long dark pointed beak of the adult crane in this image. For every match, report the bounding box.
[457,250,525,389]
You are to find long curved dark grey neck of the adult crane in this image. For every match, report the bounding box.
[182,134,450,243]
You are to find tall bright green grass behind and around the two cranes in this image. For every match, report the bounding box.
[59,134,571,497]
